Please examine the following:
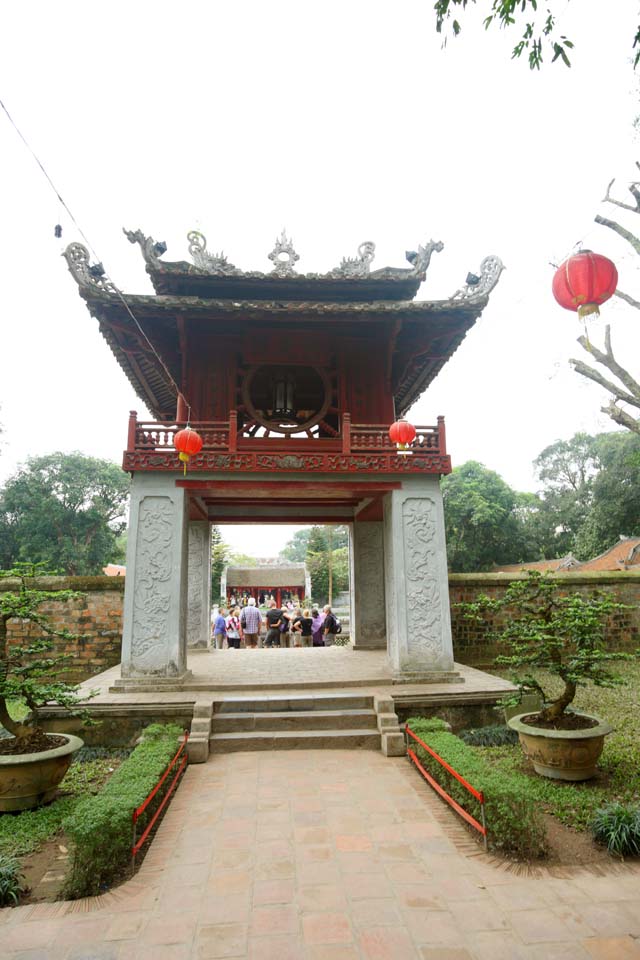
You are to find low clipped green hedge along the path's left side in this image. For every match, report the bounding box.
[63,724,182,898]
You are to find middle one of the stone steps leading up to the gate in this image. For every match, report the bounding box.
[211,710,377,733]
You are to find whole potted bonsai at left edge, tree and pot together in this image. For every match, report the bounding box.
[0,564,94,812]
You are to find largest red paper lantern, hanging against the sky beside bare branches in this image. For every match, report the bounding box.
[552,250,618,318]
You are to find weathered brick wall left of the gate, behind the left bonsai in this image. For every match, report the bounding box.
[0,577,124,683]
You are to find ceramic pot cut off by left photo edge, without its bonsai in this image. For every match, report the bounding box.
[0,733,82,813]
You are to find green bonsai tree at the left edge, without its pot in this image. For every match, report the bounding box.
[0,563,95,754]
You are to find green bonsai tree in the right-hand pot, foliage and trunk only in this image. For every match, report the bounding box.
[458,571,631,723]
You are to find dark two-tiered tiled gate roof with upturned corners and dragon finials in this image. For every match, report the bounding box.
[65,230,503,420]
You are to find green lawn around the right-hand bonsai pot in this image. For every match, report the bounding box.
[474,661,640,829]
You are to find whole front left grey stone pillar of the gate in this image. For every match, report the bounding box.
[117,473,188,686]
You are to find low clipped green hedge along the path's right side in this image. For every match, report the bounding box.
[408,717,546,860]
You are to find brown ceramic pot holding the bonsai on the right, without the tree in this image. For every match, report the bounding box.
[507,710,613,780]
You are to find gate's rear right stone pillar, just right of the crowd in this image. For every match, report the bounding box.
[350,520,387,650]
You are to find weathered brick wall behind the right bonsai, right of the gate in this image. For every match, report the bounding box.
[449,571,640,667]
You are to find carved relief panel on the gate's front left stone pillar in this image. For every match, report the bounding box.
[131,496,177,674]
